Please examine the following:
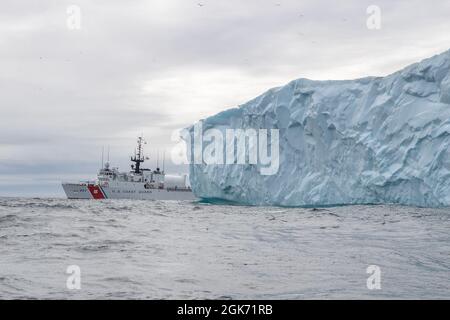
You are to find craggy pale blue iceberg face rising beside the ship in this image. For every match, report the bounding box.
[185,51,450,206]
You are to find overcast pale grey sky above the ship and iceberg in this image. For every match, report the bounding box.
[0,0,450,196]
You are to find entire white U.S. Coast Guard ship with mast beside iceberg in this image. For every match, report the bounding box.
[62,137,196,200]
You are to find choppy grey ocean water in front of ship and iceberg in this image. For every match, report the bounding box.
[0,198,450,299]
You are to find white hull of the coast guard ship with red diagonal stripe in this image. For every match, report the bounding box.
[62,183,196,200]
